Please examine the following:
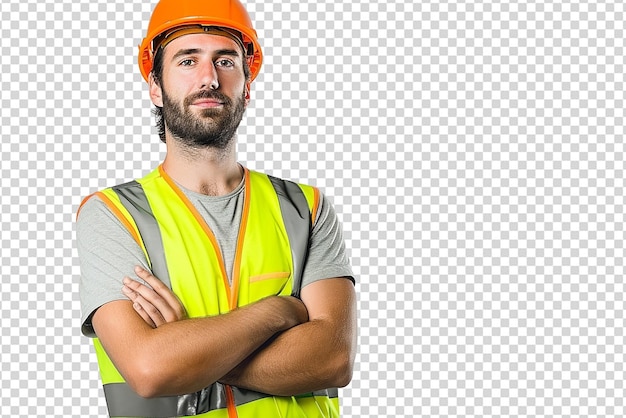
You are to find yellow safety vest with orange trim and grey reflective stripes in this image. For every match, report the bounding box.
[83,166,339,418]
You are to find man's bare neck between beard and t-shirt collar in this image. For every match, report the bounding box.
[163,140,243,196]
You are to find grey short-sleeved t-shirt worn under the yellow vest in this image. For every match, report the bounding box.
[76,171,354,337]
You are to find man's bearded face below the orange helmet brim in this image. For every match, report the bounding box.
[150,34,249,149]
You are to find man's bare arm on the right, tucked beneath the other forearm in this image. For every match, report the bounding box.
[220,279,356,396]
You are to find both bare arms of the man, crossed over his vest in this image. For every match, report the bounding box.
[92,269,356,397]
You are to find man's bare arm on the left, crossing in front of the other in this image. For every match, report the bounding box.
[93,297,306,397]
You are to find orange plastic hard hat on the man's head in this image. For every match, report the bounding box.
[139,0,263,81]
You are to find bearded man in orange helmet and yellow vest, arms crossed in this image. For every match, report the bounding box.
[77,0,356,418]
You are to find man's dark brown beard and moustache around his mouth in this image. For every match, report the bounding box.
[162,85,246,150]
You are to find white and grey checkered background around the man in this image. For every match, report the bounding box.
[0,0,626,417]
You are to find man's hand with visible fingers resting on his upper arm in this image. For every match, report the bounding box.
[122,266,187,328]
